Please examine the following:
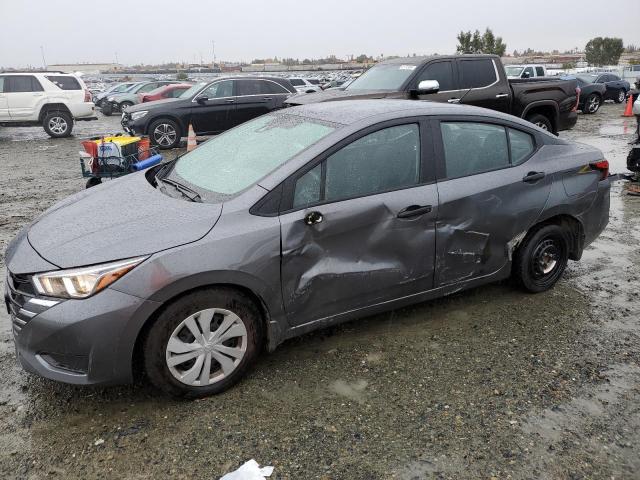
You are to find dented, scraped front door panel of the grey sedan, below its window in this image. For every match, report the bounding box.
[280,184,438,325]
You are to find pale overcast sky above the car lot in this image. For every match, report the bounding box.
[0,0,640,67]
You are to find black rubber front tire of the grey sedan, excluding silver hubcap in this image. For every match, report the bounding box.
[142,287,263,398]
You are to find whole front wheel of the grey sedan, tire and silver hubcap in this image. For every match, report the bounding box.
[143,288,262,398]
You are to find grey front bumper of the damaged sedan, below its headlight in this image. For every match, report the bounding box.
[5,278,159,385]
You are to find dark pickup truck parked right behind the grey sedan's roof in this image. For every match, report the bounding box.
[285,55,579,133]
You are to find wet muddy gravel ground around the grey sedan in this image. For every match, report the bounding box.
[0,104,640,479]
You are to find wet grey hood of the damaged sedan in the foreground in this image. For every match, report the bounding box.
[28,172,222,268]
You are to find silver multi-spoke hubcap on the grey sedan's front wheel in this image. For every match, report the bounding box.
[165,308,247,387]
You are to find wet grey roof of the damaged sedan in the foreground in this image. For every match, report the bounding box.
[284,99,531,127]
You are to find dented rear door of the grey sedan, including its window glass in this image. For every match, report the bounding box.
[434,118,553,287]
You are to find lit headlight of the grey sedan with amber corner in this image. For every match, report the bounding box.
[32,257,148,298]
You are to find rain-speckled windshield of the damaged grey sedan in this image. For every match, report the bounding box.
[169,113,337,197]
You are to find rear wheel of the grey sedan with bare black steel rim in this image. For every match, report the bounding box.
[512,225,569,293]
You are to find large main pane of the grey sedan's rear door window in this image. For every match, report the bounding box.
[440,122,509,178]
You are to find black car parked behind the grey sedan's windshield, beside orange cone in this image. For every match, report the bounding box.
[122,77,296,149]
